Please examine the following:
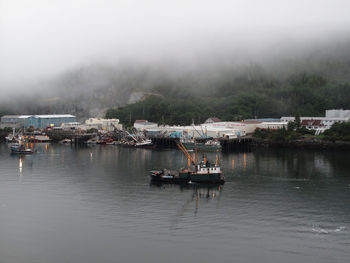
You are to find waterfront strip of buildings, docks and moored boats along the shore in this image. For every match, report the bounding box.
[0,109,350,152]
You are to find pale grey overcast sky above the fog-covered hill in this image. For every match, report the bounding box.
[0,0,350,90]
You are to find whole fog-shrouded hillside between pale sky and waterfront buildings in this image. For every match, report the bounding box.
[0,39,350,123]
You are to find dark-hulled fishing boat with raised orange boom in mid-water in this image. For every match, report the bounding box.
[151,142,225,184]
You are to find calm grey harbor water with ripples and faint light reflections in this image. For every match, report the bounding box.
[0,144,350,263]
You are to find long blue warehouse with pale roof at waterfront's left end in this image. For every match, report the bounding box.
[0,114,76,129]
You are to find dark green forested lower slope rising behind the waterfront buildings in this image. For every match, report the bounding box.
[106,73,350,125]
